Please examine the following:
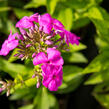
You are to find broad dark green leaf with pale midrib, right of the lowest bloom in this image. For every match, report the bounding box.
[57,65,83,93]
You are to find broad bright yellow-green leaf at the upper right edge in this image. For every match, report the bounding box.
[88,7,109,43]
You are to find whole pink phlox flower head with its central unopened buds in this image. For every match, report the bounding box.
[0,13,80,91]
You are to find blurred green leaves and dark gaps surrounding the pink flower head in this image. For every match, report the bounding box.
[0,0,109,109]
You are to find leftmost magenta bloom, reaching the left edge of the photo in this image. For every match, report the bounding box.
[0,32,19,56]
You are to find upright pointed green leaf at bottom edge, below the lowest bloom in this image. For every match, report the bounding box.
[34,87,59,109]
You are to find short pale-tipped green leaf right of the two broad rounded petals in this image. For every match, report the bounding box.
[62,52,87,63]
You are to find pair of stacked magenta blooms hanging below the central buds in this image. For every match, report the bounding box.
[33,48,64,91]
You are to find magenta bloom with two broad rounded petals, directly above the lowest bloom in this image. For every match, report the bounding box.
[33,48,64,66]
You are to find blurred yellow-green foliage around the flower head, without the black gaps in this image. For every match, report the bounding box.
[0,0,109,109]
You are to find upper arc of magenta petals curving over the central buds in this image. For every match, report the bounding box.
[16,13,80,46]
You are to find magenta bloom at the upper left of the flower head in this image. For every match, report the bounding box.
[16,13,38,28]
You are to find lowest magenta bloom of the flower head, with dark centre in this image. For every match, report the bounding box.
[41,64,63,91]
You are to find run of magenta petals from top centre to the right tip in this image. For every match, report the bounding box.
[38,13,80,45]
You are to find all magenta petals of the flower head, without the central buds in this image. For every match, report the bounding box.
[0,13,80,91]
